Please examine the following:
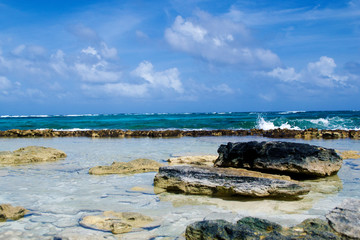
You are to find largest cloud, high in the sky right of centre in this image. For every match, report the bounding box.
[165,12,280,68]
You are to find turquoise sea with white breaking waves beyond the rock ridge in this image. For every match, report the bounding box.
[0,111,360,130]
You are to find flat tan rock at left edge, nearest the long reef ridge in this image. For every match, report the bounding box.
[0,146,66,165]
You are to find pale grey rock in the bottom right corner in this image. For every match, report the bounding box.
[326,199,360,239]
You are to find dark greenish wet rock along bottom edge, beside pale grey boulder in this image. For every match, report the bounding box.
[185,217,343,240]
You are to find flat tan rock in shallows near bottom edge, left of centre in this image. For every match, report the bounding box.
[80,211,153,234]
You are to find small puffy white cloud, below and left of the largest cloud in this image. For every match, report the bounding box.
[132,61,184,93]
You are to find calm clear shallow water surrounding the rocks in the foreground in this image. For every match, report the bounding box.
[0,137,360,239]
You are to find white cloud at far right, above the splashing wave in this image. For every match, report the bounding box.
[265,56,349,87]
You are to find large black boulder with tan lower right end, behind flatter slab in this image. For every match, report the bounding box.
[215,141,342,178]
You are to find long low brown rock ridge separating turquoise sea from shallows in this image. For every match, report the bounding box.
[0,128,360,139]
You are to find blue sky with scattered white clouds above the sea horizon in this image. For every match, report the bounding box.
[0,0,360,115]
